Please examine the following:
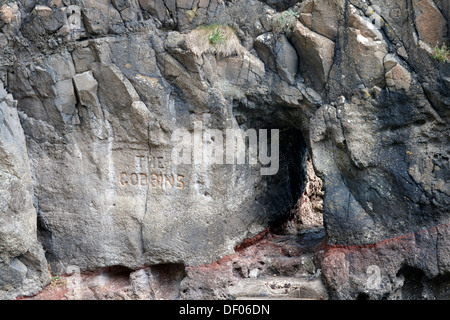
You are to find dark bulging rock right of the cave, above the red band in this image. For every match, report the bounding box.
[311,88,448,248]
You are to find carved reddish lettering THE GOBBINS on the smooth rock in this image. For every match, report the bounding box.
[119,155,185,190]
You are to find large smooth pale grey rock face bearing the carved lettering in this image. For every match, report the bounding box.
[7,27,301,278]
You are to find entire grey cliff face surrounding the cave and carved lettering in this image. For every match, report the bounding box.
[0,0,450,299]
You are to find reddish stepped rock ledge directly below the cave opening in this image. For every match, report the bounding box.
[180,229,328,300]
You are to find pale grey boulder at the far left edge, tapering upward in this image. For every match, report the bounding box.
[0,82,49,299]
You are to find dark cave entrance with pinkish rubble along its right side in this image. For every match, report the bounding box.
[233,101,324,233]
